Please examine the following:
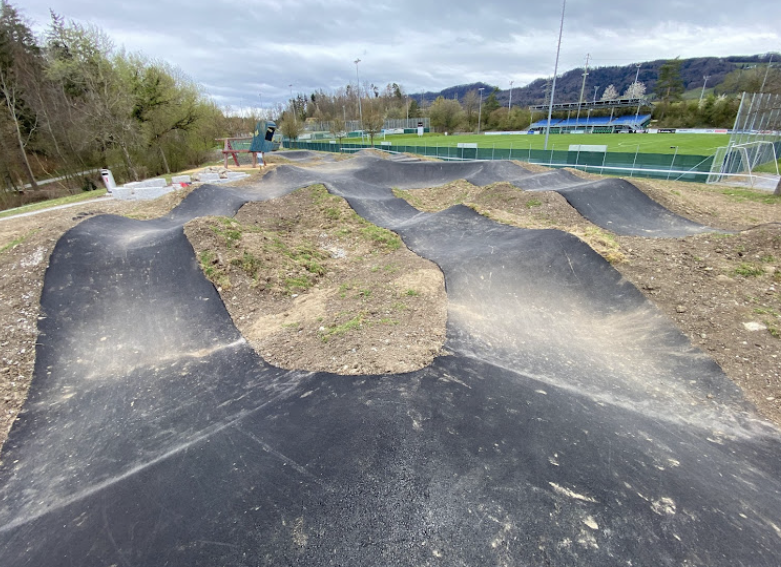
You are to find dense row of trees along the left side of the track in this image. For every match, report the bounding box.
[0,0,241,195]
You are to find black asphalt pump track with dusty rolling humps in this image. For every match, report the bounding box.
[0,156,781,567]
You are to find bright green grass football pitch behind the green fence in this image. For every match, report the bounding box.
[343,134,729,156]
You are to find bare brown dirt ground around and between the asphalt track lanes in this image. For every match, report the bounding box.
[0,156,781,458]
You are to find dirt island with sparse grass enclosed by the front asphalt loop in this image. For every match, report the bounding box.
[185,185,447,374]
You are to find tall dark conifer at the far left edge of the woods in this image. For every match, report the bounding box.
[0,1,42,189]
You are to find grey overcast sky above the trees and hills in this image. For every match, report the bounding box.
[18,0,781,107]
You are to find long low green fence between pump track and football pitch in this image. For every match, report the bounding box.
[285,141,713,183]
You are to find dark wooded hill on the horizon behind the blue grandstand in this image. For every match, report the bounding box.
[410,53,781,106]
